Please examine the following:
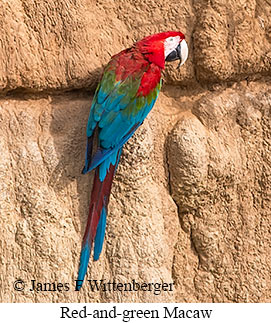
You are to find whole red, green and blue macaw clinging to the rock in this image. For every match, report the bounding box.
[76,31,188,290]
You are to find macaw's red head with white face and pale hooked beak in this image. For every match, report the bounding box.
[135,31,188,68]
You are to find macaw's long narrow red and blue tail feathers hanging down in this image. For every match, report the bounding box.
[76,149,122,291]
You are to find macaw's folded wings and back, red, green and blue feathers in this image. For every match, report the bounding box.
[83,50,161,179]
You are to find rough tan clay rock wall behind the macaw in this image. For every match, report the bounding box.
[0,0,271,302]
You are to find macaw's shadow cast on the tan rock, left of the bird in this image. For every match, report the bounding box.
[49,91,93,243]
